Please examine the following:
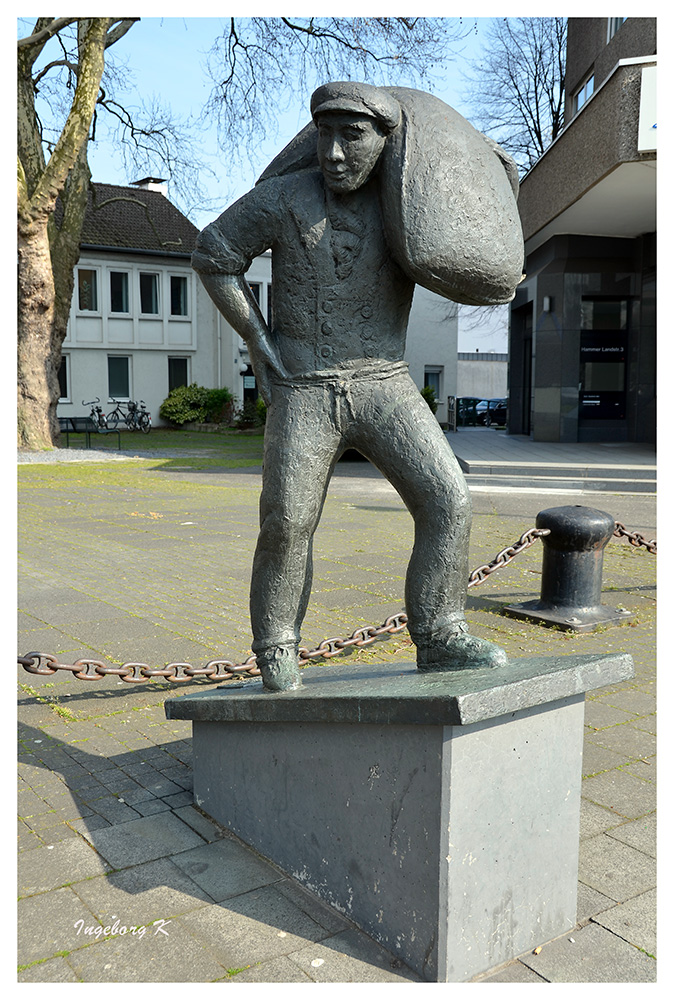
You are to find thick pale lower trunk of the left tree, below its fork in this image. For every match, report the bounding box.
[17,216,60,449]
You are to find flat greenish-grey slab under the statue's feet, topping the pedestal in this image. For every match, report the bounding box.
[165,653,634,726]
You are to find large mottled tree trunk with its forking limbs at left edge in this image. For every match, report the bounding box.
[17,17,111,449]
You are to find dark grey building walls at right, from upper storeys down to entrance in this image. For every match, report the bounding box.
[508,18,656,442]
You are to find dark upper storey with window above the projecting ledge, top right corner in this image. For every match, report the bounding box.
[565,17,657,123]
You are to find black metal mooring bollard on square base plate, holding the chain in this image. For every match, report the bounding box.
[503,505,633,632]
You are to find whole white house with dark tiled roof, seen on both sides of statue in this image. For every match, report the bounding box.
[58,178,458,426]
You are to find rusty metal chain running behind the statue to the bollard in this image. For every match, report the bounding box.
[17,521,657,684]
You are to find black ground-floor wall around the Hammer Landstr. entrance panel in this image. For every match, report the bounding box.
[508,235,655,441]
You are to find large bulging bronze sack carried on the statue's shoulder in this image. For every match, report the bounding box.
[258,87,524,305]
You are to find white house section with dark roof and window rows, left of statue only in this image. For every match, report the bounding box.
[58,178,219,422]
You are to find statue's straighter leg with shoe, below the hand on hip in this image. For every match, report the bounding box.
[250,378,341,691]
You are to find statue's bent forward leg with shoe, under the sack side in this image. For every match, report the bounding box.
[358,375,507,670]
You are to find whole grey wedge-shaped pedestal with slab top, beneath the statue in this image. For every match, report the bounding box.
[166,654,633,982]
